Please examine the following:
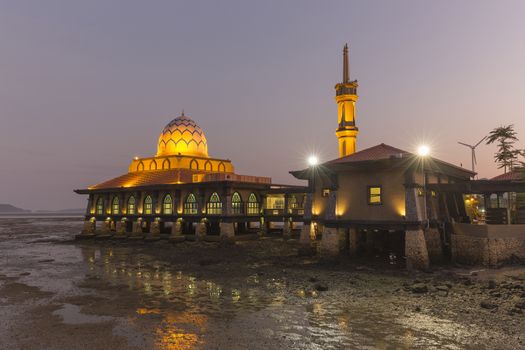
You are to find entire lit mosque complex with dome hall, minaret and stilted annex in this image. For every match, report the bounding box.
[75,45,525,269]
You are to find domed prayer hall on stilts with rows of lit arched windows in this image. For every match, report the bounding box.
[75,112,305,240]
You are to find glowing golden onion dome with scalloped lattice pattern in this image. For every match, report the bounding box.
[157,112,208,158]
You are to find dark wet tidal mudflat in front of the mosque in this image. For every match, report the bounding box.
[0,218,525,349]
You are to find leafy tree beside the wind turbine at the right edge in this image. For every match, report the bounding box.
[486,124,523,173]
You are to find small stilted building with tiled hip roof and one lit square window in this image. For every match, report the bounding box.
[291,144,474,268]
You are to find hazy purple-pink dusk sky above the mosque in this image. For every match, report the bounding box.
[0,0,525,210]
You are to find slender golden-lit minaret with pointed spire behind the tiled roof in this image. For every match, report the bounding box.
[335,44,359,157]
